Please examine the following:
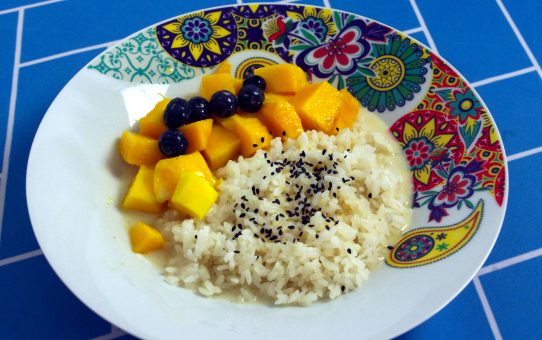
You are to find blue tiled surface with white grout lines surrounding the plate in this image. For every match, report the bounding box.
[0,0,542,339]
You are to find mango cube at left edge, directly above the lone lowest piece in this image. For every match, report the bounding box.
[122,166,164,214]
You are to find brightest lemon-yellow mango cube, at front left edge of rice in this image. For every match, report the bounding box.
[171,171,218,220]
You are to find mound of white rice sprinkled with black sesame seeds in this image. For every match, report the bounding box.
[159,114,411,305]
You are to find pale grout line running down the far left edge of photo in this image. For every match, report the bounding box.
[0,9,24,243]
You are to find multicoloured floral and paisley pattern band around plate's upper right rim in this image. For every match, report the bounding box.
[88,4,507,268]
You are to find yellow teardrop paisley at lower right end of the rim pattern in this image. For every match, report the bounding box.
[386,200,484,268]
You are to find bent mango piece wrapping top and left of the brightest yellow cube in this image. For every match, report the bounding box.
[153,151,216,202]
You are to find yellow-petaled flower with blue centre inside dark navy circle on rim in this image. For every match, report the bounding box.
[164,11,231,61]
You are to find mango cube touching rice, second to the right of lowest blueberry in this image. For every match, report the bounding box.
[201,124,241,171]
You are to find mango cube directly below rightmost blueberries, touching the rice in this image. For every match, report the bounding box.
[232,115,273,157]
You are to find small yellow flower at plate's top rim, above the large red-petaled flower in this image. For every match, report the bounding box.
[286,6,337,41]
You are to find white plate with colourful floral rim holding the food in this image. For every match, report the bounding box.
[27,5,508,339]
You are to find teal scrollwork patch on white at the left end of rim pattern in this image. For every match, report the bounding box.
[88,28,197,84]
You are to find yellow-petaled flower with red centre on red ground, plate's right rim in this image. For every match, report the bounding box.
[403,118,454,184]
